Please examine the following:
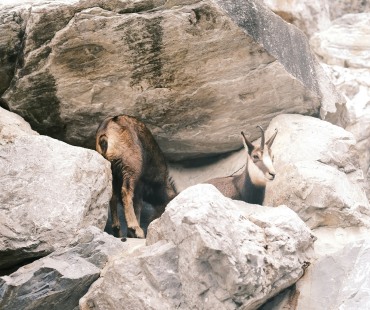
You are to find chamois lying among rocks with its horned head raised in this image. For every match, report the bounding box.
[206,126,277,205]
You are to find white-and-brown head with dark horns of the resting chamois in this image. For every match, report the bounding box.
[241,126,277,186]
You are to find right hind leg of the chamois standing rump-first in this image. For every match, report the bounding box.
[122,180,145,238]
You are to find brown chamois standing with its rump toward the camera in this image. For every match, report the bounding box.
[96,115,176,238]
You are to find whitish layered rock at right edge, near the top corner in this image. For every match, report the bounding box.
[310,13,370,68]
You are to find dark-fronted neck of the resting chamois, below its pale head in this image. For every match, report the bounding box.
[238,159,266,205]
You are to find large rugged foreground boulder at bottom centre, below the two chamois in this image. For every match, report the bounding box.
[80,185,314,309]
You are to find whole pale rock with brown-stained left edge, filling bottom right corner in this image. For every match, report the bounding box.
[261,228,370,310]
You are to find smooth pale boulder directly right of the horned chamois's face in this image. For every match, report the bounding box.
[264,115,370,228]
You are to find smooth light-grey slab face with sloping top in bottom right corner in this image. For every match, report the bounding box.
[297,239,370,310]
